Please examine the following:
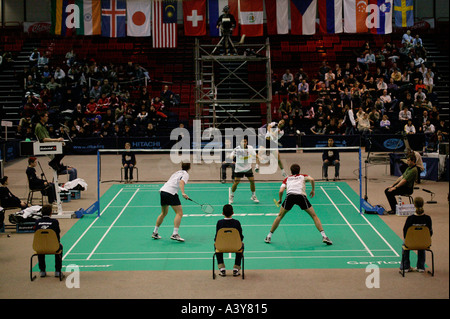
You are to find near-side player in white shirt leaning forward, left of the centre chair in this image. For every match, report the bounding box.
[152,163,191,241]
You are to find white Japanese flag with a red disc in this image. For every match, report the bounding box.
[127,0,151,37]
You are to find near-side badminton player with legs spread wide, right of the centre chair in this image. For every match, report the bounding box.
[264,164,333,245]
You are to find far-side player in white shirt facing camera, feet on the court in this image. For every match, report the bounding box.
[228,137,259,204]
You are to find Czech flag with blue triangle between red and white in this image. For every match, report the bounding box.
[291,0,317,35]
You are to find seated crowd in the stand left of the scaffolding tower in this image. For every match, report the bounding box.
[16,44,179,139]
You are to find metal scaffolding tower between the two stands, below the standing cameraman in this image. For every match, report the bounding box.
[194,38,272,129]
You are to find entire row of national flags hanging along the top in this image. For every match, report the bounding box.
[51,0,414,48]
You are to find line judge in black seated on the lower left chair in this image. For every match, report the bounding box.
[34,205,62,277]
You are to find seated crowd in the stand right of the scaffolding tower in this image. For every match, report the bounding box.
[272,30,448,148]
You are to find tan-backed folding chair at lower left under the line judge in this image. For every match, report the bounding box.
[30,229,63,281]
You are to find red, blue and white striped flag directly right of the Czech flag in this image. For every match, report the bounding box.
[318,0,342,34]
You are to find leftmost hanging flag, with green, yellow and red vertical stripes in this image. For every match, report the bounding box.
[51,0,79,36]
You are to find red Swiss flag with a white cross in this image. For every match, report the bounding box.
[183,0,206,37]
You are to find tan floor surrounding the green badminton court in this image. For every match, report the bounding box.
[0,153,449,300]
